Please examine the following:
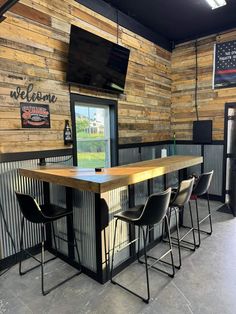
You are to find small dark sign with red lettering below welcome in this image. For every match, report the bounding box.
[20,103,50,128]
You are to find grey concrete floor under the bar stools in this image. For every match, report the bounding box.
[0,201,236,314]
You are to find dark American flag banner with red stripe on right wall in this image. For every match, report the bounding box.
[213,40,236,88]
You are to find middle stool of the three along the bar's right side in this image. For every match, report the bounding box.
[169,178,196,269]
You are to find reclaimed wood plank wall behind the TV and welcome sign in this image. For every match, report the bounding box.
[0,0,171,153]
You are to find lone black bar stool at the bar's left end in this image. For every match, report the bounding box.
[15,192,81,295]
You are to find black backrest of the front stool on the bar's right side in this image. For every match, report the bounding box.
[136,188,171,226]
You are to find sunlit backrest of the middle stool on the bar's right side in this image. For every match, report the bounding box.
[171,178,194,207]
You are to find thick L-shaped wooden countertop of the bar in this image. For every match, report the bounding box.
[19,155,203,193]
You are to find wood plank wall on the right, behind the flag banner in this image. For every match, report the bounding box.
[171,30,236,140]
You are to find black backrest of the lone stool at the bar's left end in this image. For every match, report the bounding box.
[15,192,45,223]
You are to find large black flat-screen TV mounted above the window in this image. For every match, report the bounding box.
[67,25,130,93]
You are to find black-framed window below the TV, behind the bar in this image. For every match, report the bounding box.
[71,94,117,168]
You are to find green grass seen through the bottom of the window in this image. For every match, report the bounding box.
[77,152,105,168]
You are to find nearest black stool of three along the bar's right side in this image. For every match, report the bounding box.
[111,188,175,303]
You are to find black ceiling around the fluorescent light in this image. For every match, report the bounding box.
[104,0,236,43]
